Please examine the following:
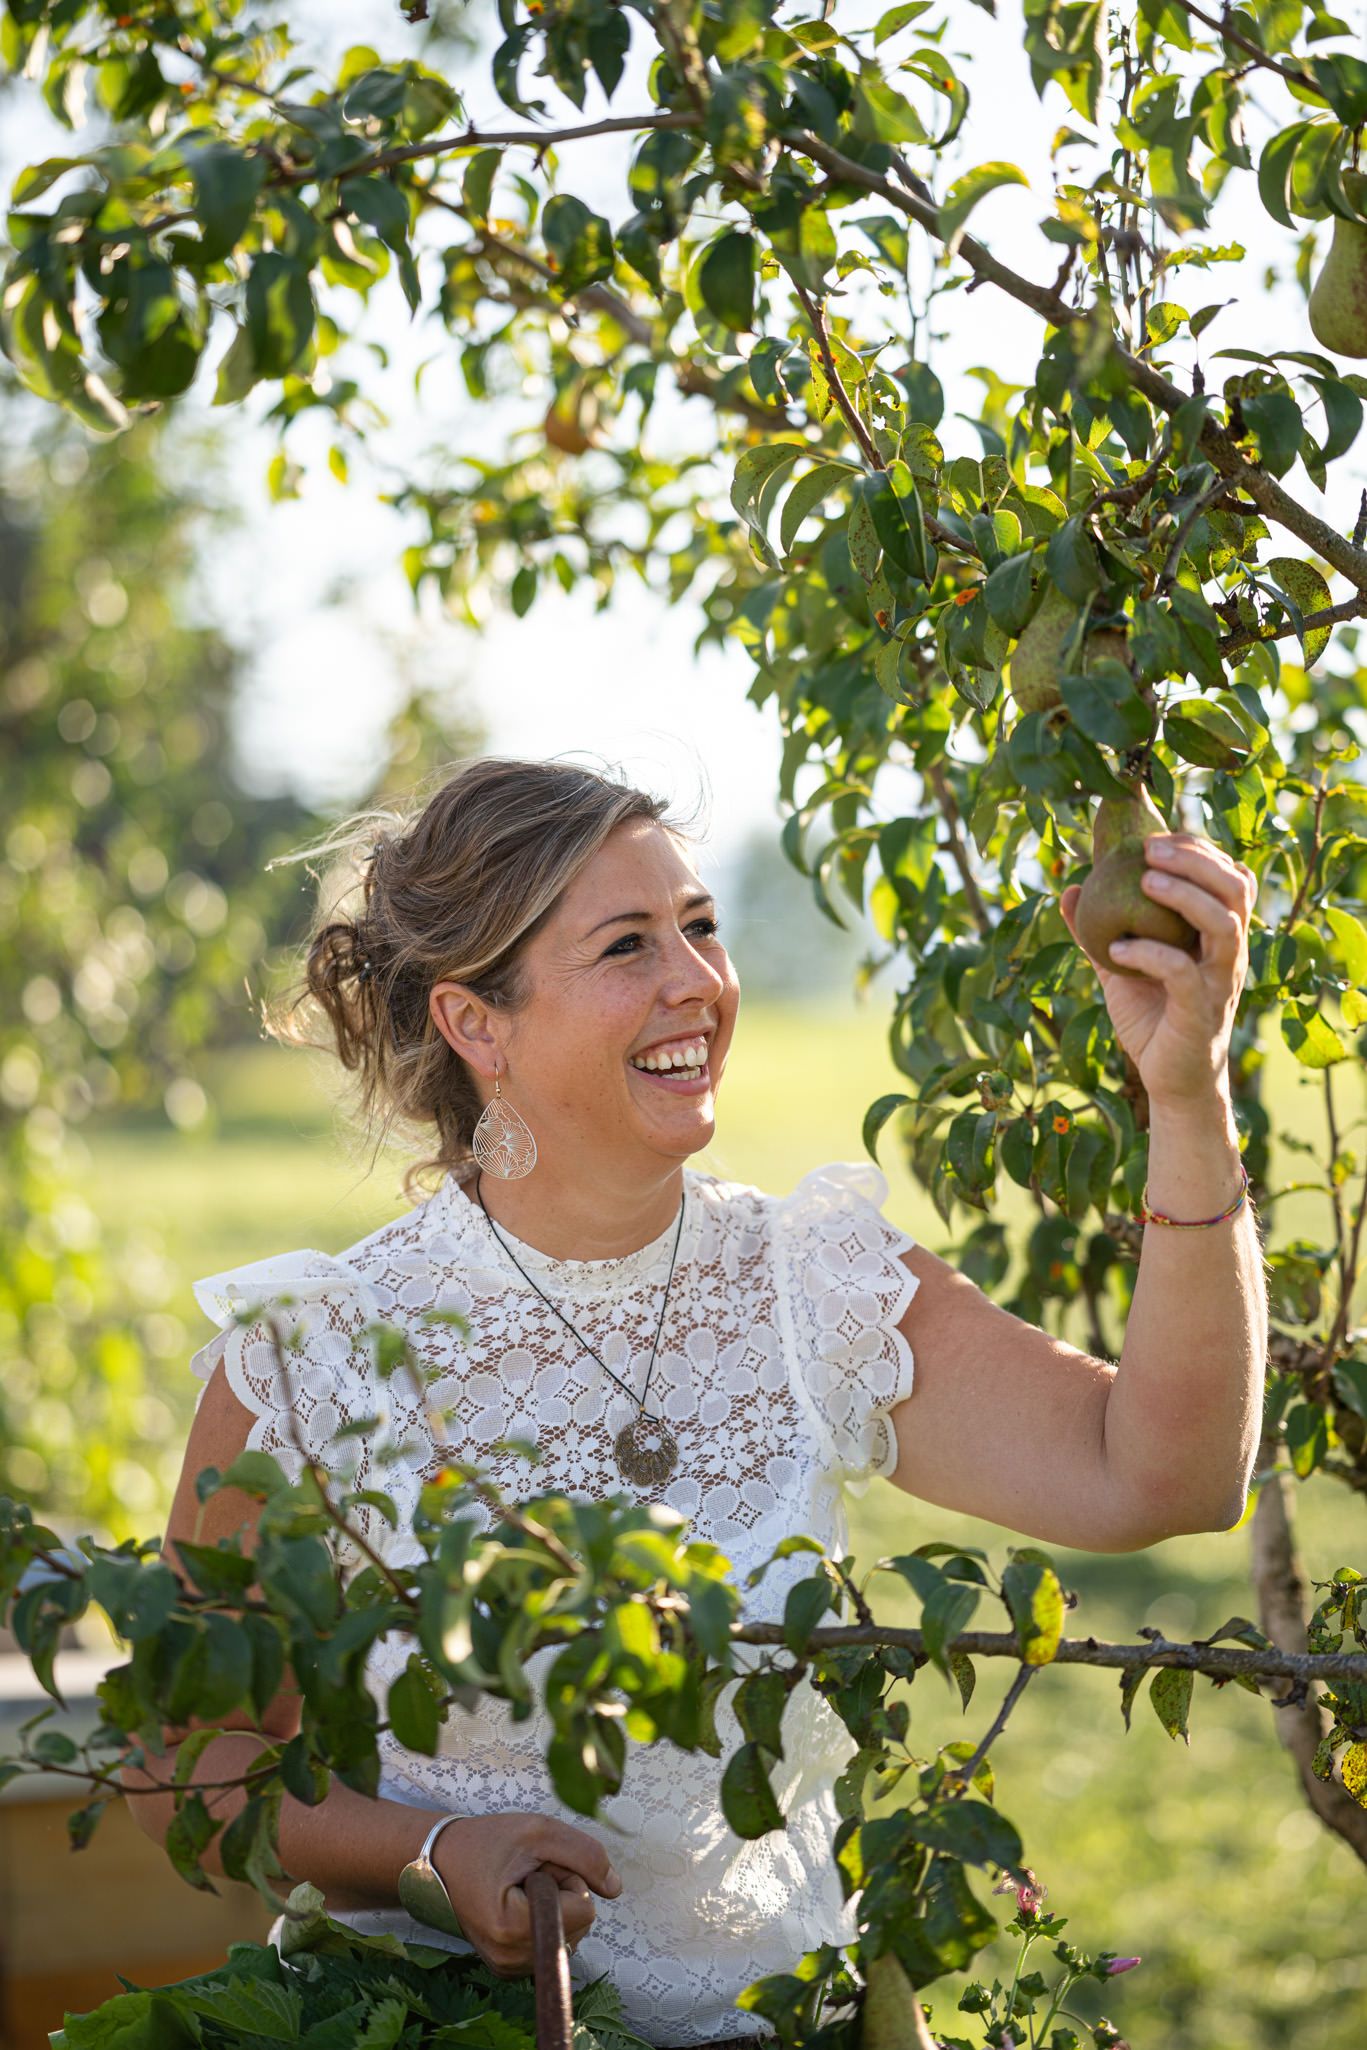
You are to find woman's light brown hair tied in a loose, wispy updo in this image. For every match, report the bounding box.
[262,756,691,1201]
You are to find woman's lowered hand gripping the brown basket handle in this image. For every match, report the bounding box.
[432,1814,621,1978]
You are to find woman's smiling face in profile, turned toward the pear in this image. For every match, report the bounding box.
[434,818,740,1169]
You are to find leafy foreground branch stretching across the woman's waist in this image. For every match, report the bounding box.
[0,1312,1367,2050]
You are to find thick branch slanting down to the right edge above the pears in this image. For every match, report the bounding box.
[779,129,1367,592]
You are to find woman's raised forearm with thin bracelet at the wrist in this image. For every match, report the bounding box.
[1105,1091,1267,1535]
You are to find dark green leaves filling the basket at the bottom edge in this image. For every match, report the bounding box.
[51,1884,646,2050]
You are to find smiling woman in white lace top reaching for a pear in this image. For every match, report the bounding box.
[125,761,1265,2046]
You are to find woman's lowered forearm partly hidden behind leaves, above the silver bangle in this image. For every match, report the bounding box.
[123,1730,444,1909]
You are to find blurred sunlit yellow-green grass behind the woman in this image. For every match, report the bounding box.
[90,1000,1367,2050]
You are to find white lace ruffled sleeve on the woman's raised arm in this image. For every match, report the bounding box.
[773,1160,920,1494]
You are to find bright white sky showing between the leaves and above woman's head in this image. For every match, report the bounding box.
[4,0,1361,897]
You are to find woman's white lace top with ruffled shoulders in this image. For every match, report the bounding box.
[193,1162,918,2046]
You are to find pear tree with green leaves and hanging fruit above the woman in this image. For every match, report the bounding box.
[0,0,1367,2041]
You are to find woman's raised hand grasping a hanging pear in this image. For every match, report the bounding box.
[1060,832,1258,1107]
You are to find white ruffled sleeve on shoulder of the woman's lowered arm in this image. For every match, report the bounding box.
[191,1248,383,1480]
